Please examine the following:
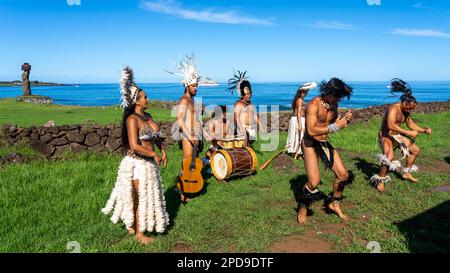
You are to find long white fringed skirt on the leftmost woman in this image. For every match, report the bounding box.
[101,156,169,233]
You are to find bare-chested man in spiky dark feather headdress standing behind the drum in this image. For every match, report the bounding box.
[226,70,263,146]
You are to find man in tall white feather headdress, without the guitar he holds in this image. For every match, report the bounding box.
[169,54,203,202]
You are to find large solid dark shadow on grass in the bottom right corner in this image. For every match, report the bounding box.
[396,201,450,253]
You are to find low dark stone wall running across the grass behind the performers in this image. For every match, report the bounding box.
[0,101,450,159]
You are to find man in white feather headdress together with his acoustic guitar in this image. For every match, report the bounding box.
[171,55,203,202]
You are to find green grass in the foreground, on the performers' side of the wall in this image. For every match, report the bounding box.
[0,111,450,252]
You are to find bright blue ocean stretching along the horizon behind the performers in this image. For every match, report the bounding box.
[0,81,450,111]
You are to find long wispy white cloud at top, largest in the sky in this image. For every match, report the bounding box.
[140,0,273,26]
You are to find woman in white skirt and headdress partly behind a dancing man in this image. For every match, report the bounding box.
[285,82,317,159]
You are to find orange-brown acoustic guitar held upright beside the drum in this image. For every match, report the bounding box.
[177,142,203,194]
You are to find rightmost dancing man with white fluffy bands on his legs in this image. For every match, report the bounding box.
[369,79,431,192]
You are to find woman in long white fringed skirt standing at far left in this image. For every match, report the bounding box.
[102,67,169,244]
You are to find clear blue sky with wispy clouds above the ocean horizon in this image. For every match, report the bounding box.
[0,0,450,83]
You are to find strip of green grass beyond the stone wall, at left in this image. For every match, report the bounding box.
[0,98,175,127]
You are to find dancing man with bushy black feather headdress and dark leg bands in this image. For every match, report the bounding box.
[297,78,353,224]
